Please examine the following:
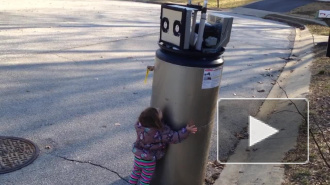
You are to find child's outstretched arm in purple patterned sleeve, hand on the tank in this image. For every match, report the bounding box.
[162,123,197,144]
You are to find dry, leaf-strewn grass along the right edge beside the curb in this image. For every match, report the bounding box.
[283,46,330,185]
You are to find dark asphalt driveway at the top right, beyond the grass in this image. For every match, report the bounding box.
[245,0,315,13]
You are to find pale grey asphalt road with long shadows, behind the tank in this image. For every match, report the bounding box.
[0,0,294,185]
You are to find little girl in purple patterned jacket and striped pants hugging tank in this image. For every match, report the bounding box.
[129,107,197,184]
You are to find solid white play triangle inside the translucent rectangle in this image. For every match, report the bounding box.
[249,116,278,147]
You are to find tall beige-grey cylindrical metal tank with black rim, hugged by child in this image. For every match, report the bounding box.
[151,49,223,185]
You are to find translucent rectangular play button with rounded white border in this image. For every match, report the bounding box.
[217,98,309,164]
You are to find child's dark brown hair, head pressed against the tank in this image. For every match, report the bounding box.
[139,107,163,129]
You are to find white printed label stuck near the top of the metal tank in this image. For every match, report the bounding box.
[202,67,222,89]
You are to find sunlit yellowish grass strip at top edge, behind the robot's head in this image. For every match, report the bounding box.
[124,0,256,9]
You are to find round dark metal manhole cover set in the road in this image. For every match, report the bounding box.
[0,136,39,174]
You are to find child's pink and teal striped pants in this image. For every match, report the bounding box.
[129,156,156,185]
